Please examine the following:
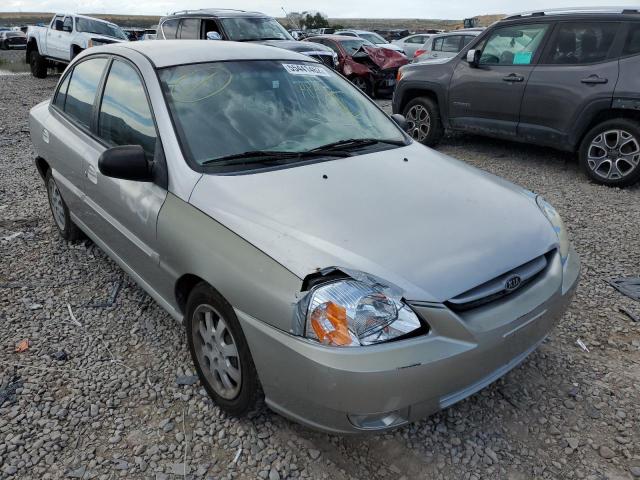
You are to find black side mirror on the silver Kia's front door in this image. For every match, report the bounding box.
[98,145,153,182]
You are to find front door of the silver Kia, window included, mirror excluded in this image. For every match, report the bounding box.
[84,59,167,285]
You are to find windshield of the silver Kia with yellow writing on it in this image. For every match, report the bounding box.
[160,60,406,168]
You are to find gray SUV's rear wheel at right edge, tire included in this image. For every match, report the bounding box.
[579,118,640,188]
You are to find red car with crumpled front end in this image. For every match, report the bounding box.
[304,35,409,96]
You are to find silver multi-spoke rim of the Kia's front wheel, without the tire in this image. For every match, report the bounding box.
[192,305,242,400]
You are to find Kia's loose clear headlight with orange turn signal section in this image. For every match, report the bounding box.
[298,274,423,347]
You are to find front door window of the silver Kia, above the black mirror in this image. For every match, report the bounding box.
[98,60,156,160]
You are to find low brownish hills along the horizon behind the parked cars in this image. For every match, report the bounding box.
[0,12,503,31]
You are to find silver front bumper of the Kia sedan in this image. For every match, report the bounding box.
[238,250,580,433]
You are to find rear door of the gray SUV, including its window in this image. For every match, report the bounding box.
[518,21,623,149]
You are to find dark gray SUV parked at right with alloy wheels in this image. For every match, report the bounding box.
[393,8,640,187]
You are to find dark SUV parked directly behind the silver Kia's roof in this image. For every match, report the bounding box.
[158,9,338,68]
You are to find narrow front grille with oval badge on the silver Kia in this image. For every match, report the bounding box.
[445,250,555,312]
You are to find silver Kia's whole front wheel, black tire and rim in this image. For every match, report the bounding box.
[185,282,262,416]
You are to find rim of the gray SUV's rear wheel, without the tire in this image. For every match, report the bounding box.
[587,129,640,180]
